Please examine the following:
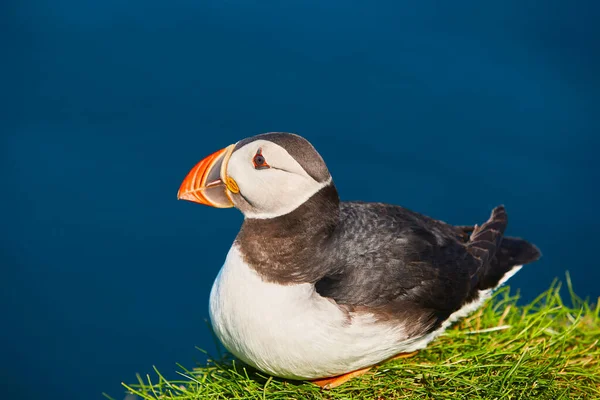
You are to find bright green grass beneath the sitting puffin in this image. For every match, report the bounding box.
[106,275,600,400]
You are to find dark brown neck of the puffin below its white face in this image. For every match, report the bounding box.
[236,183,340,284]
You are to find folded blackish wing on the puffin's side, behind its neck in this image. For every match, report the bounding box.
[316,203,507,334]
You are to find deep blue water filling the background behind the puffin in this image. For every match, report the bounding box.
[0,0,600,399]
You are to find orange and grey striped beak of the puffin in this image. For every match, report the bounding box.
[177,144,239,208]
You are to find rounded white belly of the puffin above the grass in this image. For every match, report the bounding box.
[210,245,438,379]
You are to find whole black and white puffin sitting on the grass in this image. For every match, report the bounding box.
[177,132,541,389]
